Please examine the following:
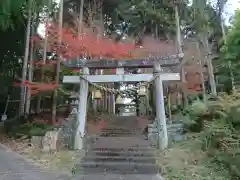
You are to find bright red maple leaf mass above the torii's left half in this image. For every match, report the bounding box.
[34,25,136,60]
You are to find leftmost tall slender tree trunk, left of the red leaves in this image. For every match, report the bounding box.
[19,0,33,116]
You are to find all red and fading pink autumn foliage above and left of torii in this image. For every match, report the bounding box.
[17,19,179,95]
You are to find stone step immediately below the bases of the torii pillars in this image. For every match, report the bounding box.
[86,151,153,157]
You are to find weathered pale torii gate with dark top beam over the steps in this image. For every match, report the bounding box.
[63,54,183,149]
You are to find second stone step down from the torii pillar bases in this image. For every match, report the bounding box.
[84,156,156,164]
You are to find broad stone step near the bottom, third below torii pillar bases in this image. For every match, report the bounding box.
[75,161,159,174]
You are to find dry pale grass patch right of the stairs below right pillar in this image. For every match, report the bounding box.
[156,134,230,180]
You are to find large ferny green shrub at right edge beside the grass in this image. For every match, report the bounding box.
[183,93,240,179]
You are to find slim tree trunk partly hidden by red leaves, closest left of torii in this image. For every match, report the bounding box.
[52,0,63,123]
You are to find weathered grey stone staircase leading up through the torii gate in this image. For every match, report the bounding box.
[71,117,159,180]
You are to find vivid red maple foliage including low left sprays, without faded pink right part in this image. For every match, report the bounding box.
[14,24,137,95]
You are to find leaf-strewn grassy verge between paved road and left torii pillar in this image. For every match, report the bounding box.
[0,122,84,174]
